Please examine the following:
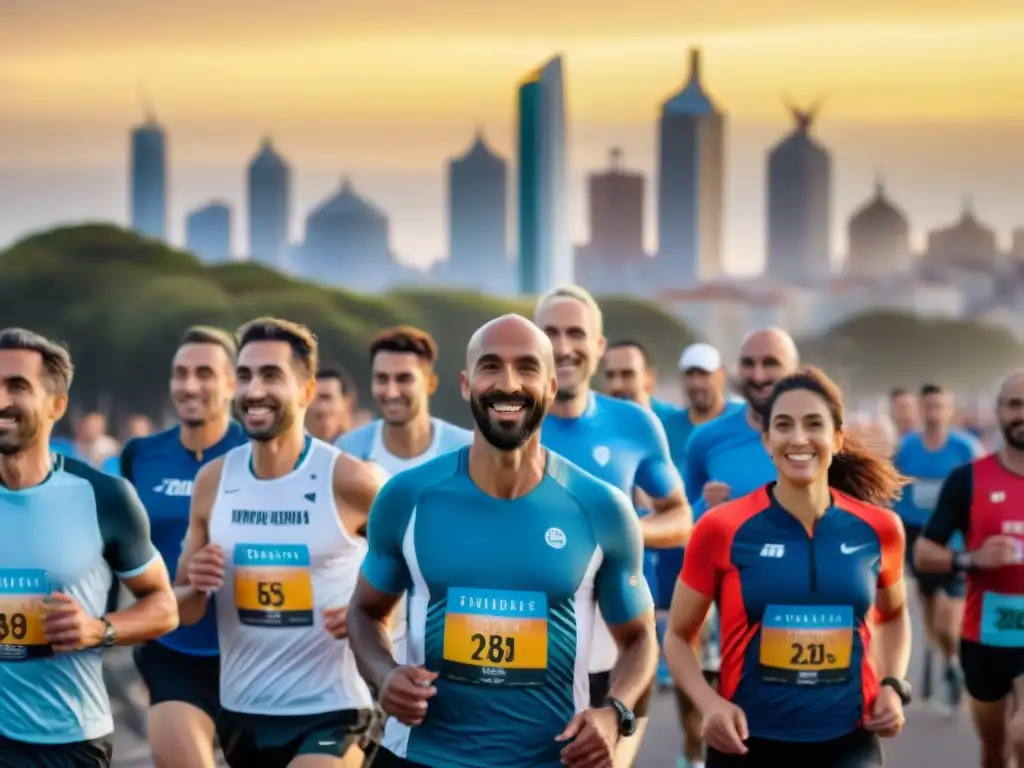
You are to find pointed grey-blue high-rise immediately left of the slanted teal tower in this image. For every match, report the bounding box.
[447,131,508,275]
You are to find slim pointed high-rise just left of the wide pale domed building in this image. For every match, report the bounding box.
[246,138,292,268]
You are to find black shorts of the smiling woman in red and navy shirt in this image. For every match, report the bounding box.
[707,730,885,768]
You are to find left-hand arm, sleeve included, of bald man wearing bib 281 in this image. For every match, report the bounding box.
[348,475,416,690]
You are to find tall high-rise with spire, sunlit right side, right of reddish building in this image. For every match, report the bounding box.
[657,48,726,283]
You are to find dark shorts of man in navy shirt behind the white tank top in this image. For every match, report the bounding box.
[132,642,220,721]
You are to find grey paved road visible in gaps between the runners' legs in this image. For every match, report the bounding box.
[114,598,978,768]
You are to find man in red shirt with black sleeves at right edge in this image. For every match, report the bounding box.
[914,372,1024,768]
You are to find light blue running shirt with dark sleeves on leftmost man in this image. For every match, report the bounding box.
[0,455,160,744]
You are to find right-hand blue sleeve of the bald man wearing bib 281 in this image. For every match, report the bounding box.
[591,487,654,626]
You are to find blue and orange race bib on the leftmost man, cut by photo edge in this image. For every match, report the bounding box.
[0,568,53,662]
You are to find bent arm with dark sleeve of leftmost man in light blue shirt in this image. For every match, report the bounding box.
[94,476,178,645]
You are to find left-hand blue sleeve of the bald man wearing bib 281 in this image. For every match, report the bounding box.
[362,475,416,595]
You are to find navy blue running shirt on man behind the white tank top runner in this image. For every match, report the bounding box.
[121,422,246,656]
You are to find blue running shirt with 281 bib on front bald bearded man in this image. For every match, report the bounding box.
[362,449,651,768]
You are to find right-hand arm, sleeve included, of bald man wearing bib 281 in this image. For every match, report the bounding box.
[592,490,657,709]
